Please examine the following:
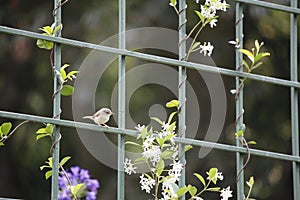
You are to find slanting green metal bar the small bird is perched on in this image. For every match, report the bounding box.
[0,111,300,163]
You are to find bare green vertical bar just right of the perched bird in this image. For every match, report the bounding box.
[118,0,126,200]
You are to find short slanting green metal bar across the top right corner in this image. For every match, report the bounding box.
[234,0,300,15]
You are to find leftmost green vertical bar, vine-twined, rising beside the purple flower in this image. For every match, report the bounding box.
[51,0,61,200]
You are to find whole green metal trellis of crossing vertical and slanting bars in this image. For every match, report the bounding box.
[0,0,300,200]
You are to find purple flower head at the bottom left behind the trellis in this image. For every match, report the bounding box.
[58,166,100,200]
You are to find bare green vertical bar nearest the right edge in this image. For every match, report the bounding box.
[290,0,300,199]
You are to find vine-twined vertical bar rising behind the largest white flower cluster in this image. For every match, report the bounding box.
[178,0,187,200]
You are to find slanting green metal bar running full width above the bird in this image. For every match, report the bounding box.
[0,26,300,88]
